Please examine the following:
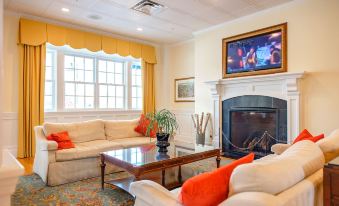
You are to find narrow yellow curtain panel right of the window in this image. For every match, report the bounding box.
[142,61,155,114]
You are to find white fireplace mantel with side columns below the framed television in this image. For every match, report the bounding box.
[206,72,305,146]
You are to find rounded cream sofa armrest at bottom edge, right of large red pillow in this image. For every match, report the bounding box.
[219,192,287,206]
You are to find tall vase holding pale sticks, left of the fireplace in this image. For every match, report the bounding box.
[192,112,211,145]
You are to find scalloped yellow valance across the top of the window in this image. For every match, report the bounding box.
[19,18,157,64]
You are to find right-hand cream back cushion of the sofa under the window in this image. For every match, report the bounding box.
[104,119,143,140]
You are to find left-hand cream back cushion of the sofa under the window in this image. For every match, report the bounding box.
[43,120,106,143]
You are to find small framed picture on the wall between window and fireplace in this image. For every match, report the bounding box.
[174,77,195,102]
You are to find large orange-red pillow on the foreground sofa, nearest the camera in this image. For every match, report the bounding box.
[179,153,254,206]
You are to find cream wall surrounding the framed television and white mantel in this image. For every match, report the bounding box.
[195,0,339,134]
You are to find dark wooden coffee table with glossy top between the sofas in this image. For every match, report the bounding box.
[100,142,220,192]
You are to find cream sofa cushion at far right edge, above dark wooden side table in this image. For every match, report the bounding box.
[316,129,339,162]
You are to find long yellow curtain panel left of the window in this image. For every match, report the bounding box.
[18,44,46,158]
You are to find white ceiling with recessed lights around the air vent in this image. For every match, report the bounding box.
[5,0,291,44]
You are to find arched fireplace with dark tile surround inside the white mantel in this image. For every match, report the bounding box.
[222,95,287,158]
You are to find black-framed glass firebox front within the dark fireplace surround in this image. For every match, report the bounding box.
[229,108,278,155]
